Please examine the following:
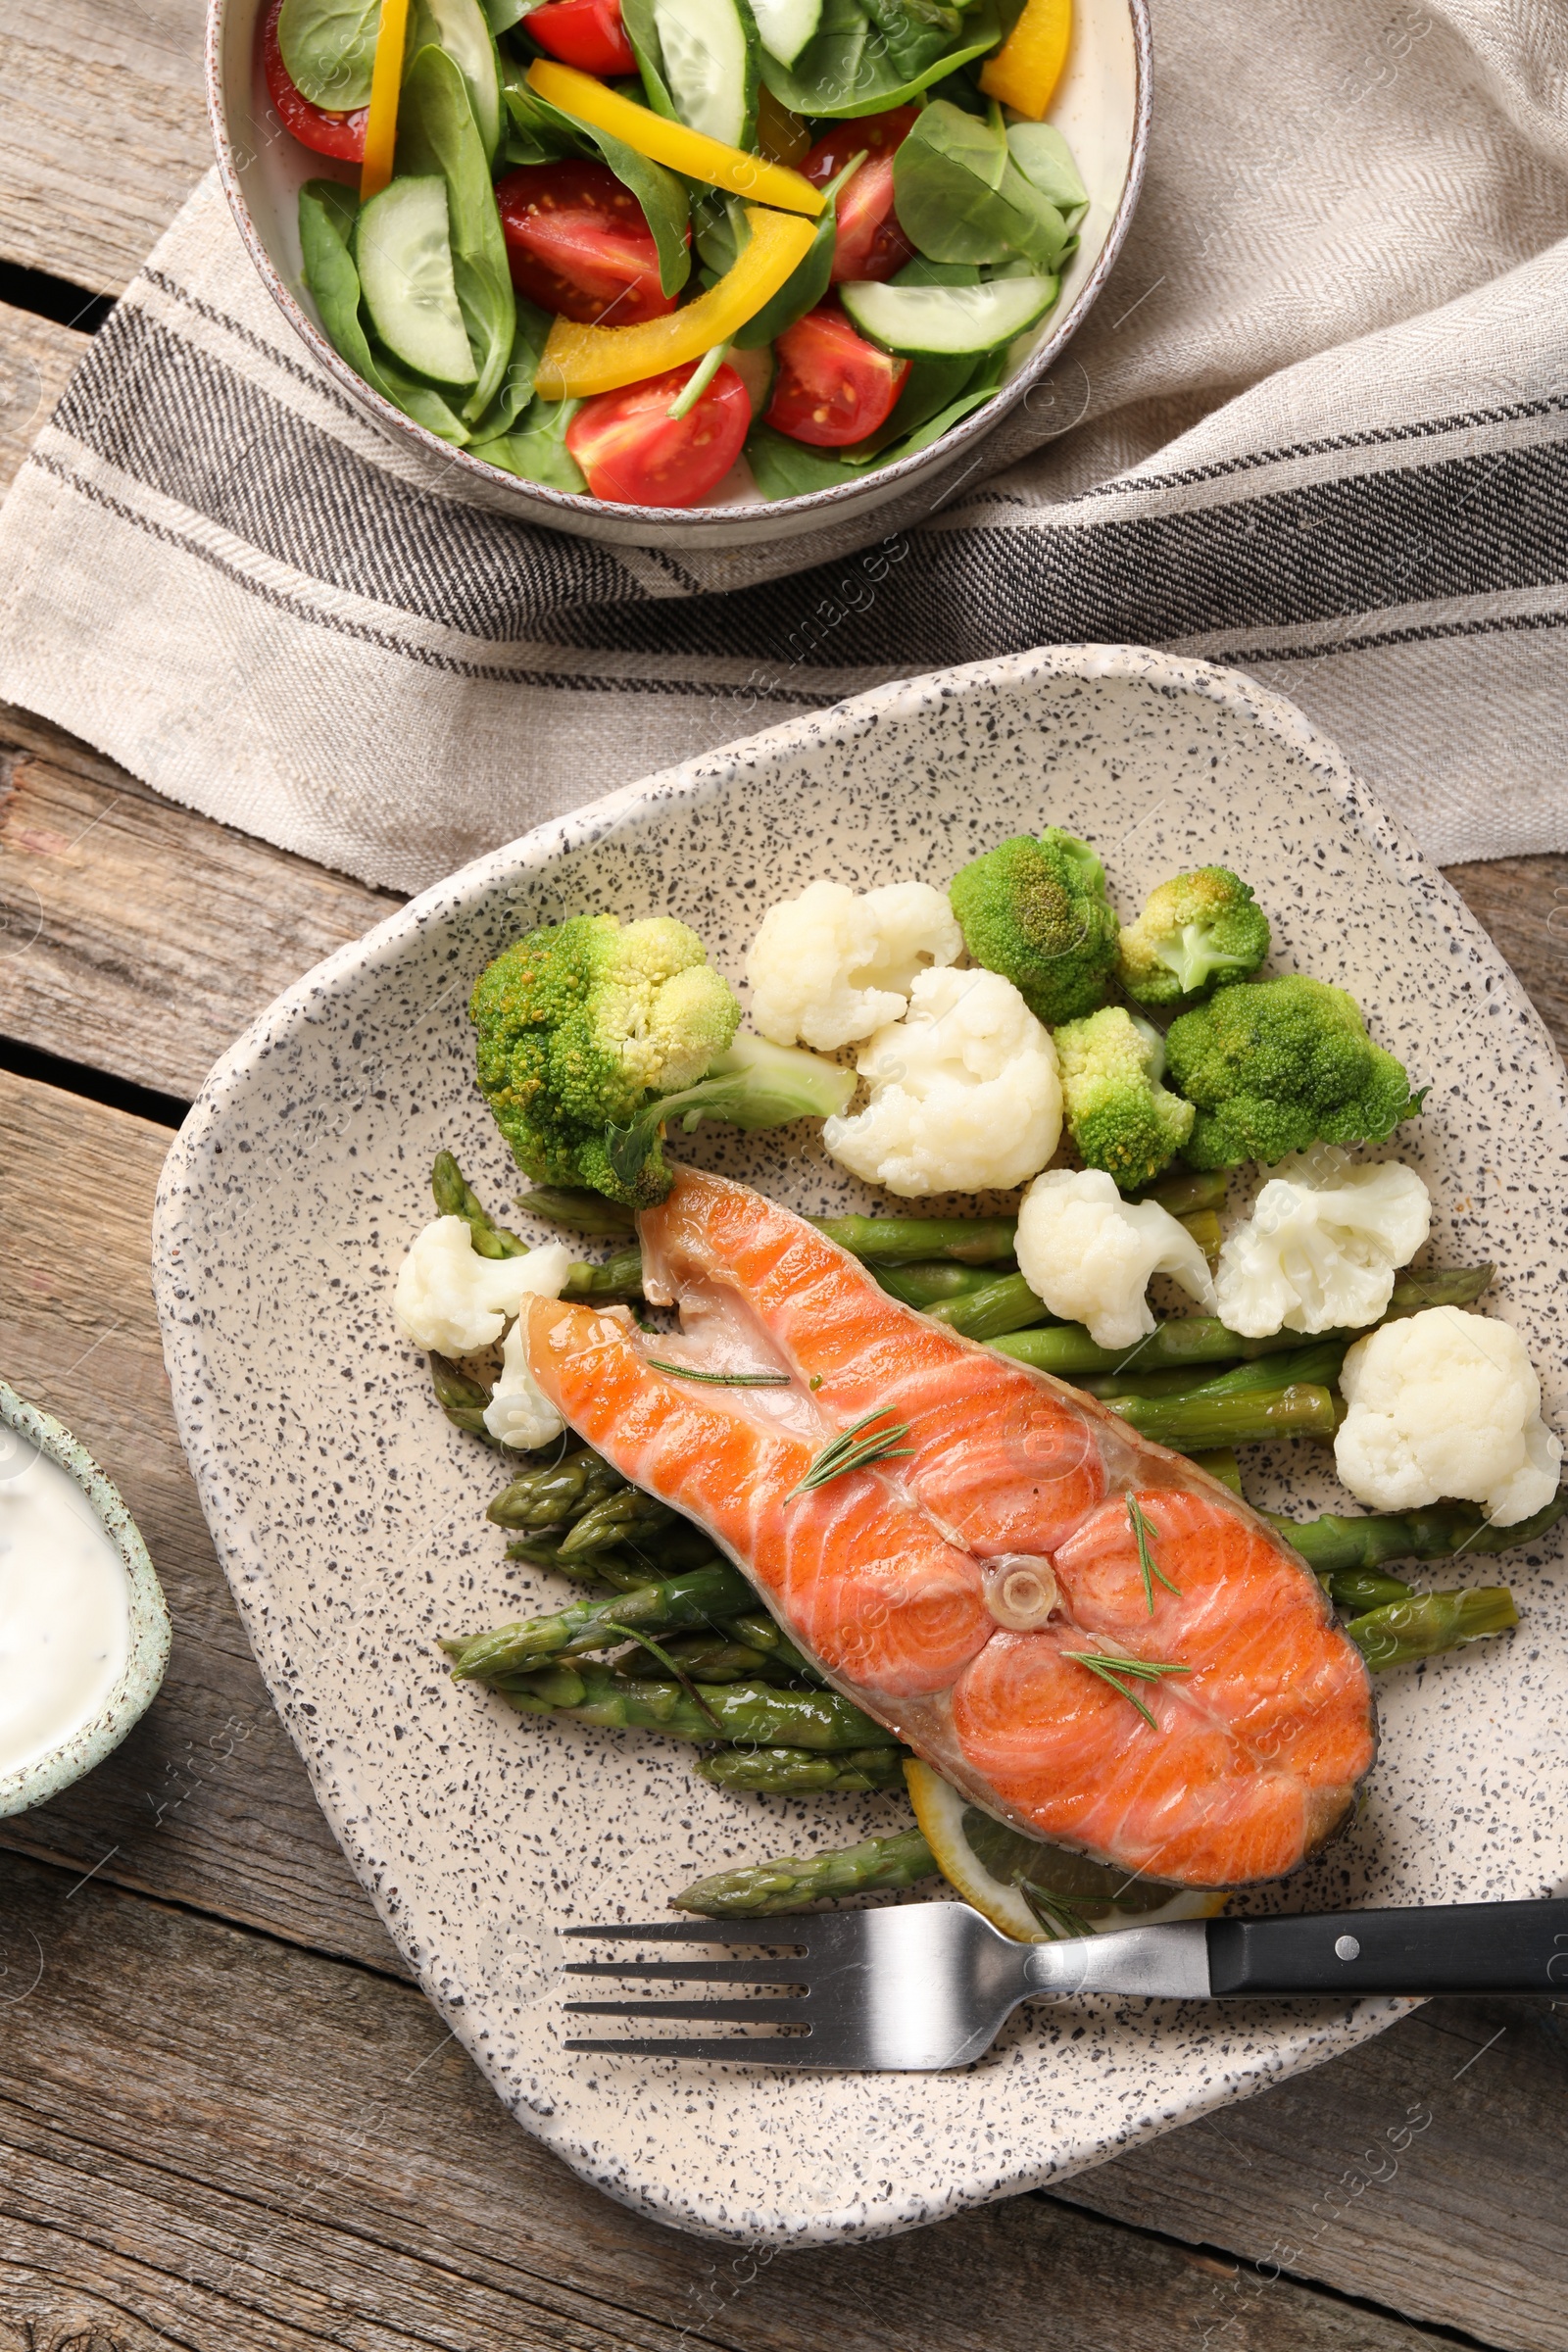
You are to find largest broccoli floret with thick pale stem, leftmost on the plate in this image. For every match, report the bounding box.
[467,915,856,1209]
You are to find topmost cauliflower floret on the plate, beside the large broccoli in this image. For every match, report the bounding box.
[745,882,964,1054]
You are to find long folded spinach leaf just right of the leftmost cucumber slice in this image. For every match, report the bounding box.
[397,47,517,421]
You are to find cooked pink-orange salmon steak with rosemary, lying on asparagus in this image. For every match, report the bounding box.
[524,1169,1375,1888]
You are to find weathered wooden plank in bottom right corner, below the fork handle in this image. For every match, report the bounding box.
[1060,2001,1568,2352]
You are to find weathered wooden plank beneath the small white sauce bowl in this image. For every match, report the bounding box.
[0,1072,402,1966]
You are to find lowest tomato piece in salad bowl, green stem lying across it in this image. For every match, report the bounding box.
[566,360,753,506]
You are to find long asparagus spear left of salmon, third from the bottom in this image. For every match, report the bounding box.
[494,1660,898,1750]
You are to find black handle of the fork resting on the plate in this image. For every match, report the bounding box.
[1208,1895,1568,1994]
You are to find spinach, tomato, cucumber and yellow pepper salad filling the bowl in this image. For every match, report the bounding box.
[259,0,1089,506]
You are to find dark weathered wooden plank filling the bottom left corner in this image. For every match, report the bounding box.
[0,1858,1457,2352]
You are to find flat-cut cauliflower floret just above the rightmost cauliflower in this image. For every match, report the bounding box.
[1213,1152,1432,1339]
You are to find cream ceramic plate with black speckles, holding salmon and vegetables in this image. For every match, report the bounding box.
[155,647,1568,2244]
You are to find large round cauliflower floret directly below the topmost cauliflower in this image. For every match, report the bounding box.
[823,971,1067,1200]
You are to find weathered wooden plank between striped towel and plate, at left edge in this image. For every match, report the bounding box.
[0,719,400,1101]
